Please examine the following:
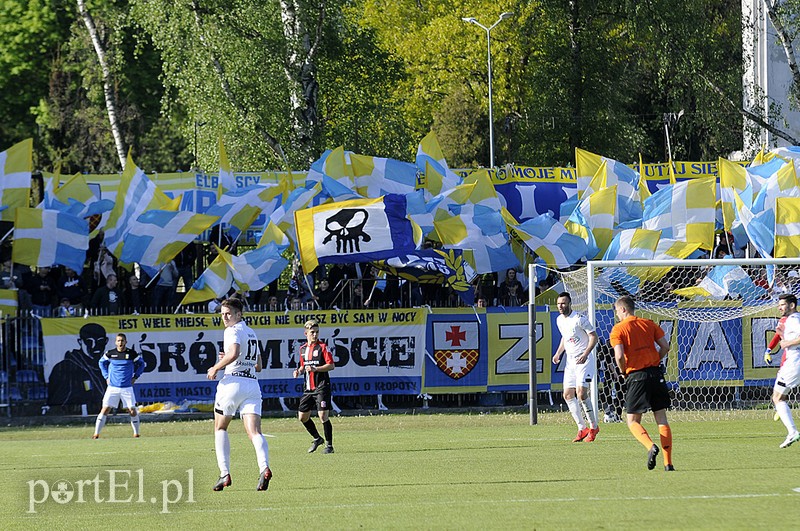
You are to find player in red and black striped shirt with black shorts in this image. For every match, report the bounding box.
[294,320,335,454]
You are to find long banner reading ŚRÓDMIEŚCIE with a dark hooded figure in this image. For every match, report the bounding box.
[42,309,425,405]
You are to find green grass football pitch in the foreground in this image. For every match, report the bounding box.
[0,410,800,529]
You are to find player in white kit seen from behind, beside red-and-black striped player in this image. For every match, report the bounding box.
[208,298,272,491]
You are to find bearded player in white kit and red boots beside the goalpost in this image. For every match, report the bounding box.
[553,291,600,442]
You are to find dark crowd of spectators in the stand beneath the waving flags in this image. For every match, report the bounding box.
[0,232,536,317]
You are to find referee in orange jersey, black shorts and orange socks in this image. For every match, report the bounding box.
[610,296,675,472]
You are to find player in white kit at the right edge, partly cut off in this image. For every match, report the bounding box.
[772,293,800,448]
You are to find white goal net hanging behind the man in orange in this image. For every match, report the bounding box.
[540,259,800,422]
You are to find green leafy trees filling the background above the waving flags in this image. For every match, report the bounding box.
[0,0,776,173]
